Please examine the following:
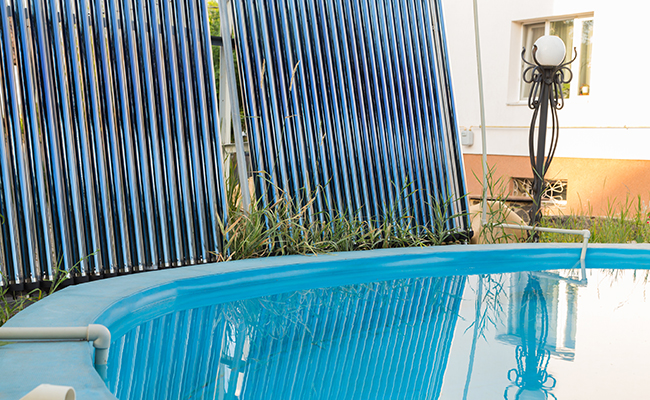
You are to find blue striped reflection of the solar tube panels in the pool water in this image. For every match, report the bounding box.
[107,277,466,400]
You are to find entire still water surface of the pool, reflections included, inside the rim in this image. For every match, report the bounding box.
[100,248,650,400]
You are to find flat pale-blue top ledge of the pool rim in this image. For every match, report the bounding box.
[0,244,650,400]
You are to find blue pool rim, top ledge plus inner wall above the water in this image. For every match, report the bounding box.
[0,244,650,400]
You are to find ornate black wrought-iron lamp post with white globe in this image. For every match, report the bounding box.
[521,36,577,241]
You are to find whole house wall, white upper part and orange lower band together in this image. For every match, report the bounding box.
[443,0,650,214]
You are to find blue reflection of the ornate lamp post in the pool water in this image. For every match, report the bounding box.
[503,275,556,400]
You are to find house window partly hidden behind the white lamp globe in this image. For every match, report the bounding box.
[519,17,594,100]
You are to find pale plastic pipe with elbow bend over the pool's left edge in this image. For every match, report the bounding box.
[0,324,111,366]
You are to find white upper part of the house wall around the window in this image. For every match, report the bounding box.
[442,0,650,160]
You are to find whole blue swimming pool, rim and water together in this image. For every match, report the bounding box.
[0,245,650,399]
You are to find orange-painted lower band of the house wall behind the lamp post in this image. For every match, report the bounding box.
[463,154,650,215]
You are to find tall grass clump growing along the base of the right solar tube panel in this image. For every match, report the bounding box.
[216,177,462,260]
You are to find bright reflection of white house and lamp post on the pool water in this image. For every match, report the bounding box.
[446,269,650,400]
